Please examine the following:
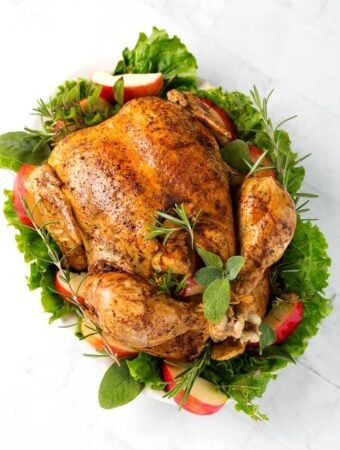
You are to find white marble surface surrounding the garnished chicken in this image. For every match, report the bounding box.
[0,0,340,450]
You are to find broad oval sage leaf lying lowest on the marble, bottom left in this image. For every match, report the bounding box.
[98,359,144,409]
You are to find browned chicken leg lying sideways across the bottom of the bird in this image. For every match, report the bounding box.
[84,272,208,349]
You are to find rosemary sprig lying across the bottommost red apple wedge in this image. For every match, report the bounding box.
[164,346,210,407]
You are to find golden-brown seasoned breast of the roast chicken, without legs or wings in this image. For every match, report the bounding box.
[49,97,235,278]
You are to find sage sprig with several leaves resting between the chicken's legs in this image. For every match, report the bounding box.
[195,249,245,323]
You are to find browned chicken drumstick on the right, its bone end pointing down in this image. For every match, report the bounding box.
[235,177,296,294]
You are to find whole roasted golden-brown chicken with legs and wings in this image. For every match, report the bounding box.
[26,91,296,361]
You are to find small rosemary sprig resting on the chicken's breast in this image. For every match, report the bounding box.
[146,203,201,248]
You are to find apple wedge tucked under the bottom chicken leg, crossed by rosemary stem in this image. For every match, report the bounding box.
[80,319,138,358]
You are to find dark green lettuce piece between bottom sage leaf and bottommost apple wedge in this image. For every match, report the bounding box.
[126,353,165,391]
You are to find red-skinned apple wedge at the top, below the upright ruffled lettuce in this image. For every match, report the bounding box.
[90,70,163,102]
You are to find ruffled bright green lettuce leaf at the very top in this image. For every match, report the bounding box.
[114,27,197,90]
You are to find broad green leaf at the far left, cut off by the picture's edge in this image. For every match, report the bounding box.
[0,131,51,172]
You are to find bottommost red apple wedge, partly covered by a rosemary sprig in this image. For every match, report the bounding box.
[162,361,228,416]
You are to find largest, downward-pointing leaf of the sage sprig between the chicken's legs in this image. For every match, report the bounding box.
[203,278,230,323]
